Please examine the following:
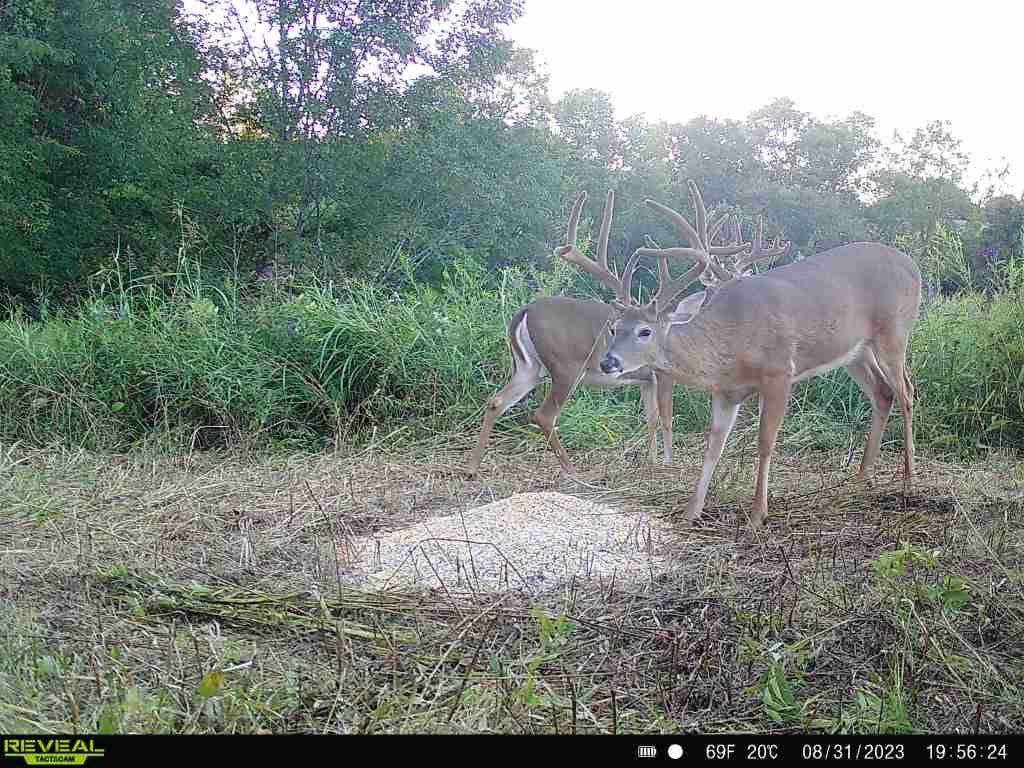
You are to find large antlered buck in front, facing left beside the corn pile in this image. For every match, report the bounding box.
[601,181,922,527]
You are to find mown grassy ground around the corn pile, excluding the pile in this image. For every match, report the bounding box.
[0,430,1024,733]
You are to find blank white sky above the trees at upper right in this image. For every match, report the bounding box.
[511,0,1024,195]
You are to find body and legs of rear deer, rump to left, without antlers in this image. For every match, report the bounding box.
[466,296,673,476]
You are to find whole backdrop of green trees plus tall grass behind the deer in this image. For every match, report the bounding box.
[0,0,1024,466]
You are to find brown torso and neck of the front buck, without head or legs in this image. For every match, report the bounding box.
[638,243,921,393]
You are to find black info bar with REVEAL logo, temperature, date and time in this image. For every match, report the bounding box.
[0,731,1021,768]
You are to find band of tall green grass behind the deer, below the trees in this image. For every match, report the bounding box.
[0,250,1024,453]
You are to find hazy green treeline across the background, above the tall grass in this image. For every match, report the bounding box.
[0,0,1024,309]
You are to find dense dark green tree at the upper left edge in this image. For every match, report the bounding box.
[0,0,220,305]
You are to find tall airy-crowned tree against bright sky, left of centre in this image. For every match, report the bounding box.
[201,0,536,270]
